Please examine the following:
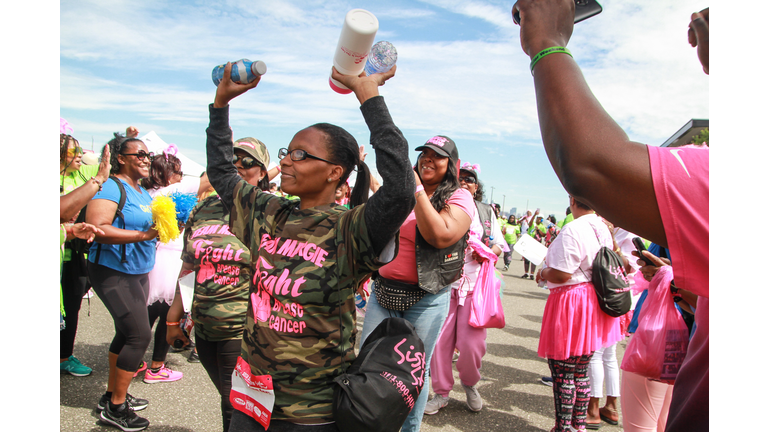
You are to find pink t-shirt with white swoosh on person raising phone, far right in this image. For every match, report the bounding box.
[648,146,709,298]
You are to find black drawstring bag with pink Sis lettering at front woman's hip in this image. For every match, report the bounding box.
[333,318,426,432]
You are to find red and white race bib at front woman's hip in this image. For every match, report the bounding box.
[229,357,275,429]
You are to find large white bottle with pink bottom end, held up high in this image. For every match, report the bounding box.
[328,9,379,94]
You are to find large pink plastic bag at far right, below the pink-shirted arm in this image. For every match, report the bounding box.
[621,266,689,384]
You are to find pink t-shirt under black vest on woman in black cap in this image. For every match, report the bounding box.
[379,189,477,285]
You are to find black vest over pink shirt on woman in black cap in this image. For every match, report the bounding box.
[416,226,468,294]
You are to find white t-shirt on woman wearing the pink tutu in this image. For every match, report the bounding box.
[545,213,613,289]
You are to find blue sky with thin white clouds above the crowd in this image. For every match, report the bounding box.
[59,0,709,219]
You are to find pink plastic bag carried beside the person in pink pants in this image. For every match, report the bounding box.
[469,237,506,328]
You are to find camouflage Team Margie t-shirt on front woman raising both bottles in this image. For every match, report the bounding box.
[230,181,384,424]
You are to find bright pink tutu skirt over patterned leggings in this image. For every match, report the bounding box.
[538,282,622,360]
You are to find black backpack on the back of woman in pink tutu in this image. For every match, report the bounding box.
[590,225,632,317]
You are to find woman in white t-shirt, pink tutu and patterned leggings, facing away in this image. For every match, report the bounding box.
[536,197,621,432]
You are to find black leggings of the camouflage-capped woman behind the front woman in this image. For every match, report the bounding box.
[195,335,243,432]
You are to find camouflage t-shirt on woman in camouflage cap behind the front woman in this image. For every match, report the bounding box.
[181,195,251,342]
